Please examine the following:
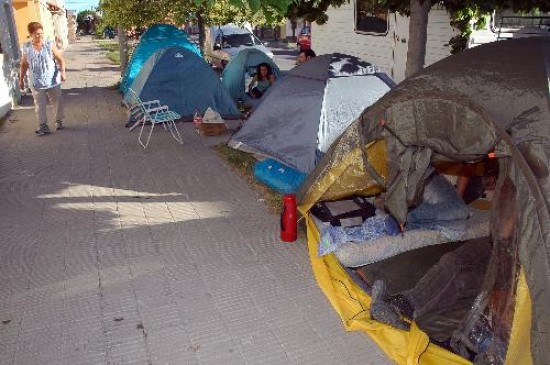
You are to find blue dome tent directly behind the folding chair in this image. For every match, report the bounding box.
[131,47,240,120]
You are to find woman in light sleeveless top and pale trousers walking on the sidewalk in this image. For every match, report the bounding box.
[19,22,67,136]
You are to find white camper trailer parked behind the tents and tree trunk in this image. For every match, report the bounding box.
[311,0,550,82]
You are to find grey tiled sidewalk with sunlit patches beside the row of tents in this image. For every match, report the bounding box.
[0,38,390,365]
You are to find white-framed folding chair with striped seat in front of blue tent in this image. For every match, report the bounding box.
[124,89,183,148]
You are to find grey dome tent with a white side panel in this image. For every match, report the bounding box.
[229,53,395,173]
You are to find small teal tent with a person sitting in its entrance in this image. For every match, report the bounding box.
[222,48,283,101]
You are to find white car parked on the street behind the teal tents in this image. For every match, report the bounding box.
[207,24,274,68]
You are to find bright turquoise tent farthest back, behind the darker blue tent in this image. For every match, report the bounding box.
[120,24,201,94]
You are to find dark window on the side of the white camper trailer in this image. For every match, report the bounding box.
[355,0,389,35]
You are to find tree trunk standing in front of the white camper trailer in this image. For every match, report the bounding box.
[405,0,431,78]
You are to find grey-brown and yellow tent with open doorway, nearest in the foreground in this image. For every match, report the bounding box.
[299,37,550,364]
